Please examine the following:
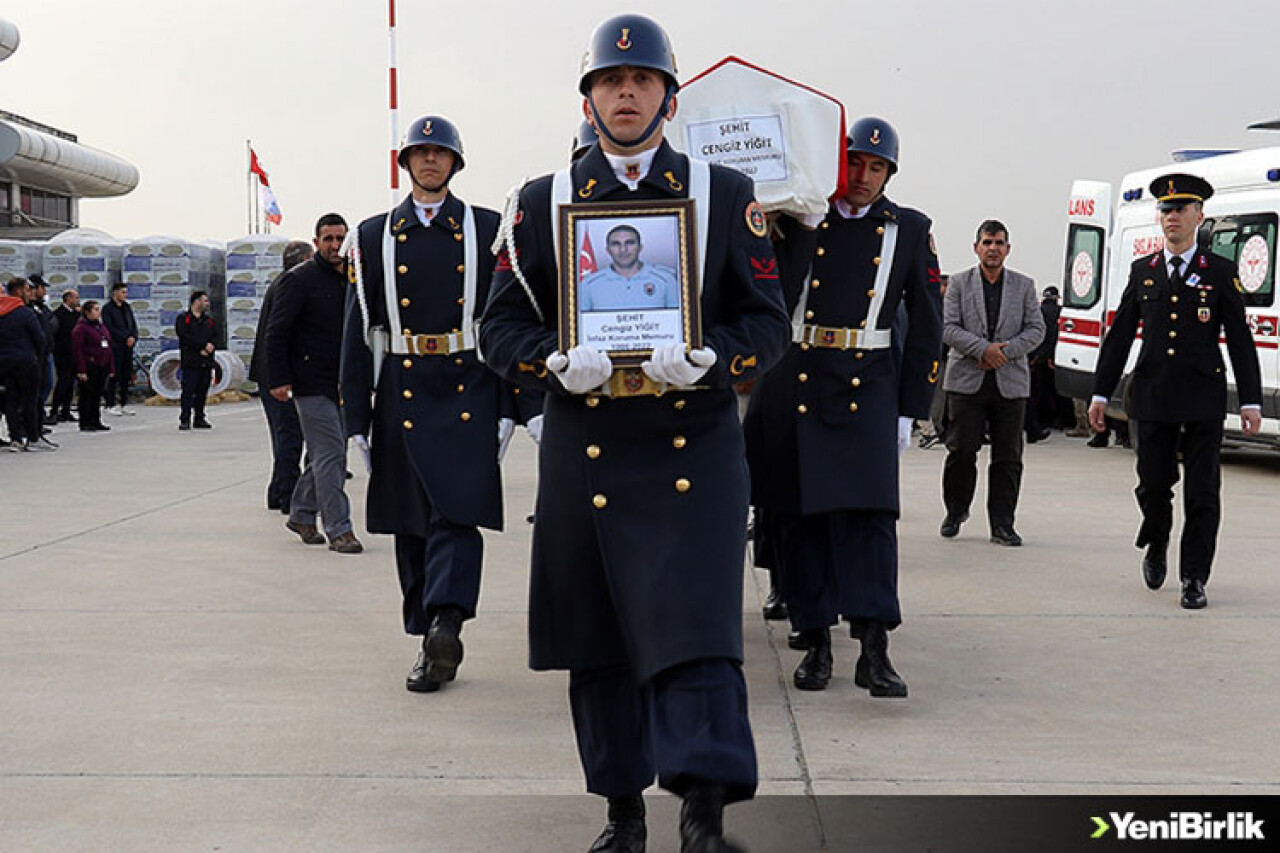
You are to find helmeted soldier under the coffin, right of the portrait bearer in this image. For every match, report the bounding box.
[744,118,942,697]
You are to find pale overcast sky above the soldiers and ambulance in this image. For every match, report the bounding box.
[0,0,1280,284]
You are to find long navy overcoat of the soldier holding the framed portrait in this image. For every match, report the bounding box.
[480,142,790,683]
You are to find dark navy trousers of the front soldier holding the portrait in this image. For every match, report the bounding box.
[568,658,758,802]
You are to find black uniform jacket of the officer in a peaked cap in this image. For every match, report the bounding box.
[1093,250,1262,423]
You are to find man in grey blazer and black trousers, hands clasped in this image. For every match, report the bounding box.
[941,219,1044,537]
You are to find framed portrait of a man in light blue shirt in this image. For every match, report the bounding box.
[559,199,701,366]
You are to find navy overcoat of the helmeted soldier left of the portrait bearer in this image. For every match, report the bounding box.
[342,193,503,537]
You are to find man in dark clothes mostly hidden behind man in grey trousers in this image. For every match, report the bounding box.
[248,240,314,515]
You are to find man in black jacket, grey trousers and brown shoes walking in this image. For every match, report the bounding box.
[266,214,365,553]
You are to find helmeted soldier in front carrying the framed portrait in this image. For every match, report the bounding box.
[480,15,787,852]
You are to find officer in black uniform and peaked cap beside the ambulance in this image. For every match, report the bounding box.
[1089,173,1262,610]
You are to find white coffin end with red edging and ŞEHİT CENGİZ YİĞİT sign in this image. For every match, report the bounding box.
[667,56,846,215]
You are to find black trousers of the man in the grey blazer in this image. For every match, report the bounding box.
[942,371,1027,529]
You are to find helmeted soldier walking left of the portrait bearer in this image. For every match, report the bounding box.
[342,115,511,693]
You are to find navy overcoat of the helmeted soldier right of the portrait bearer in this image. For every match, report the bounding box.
[745,197,942,515]
